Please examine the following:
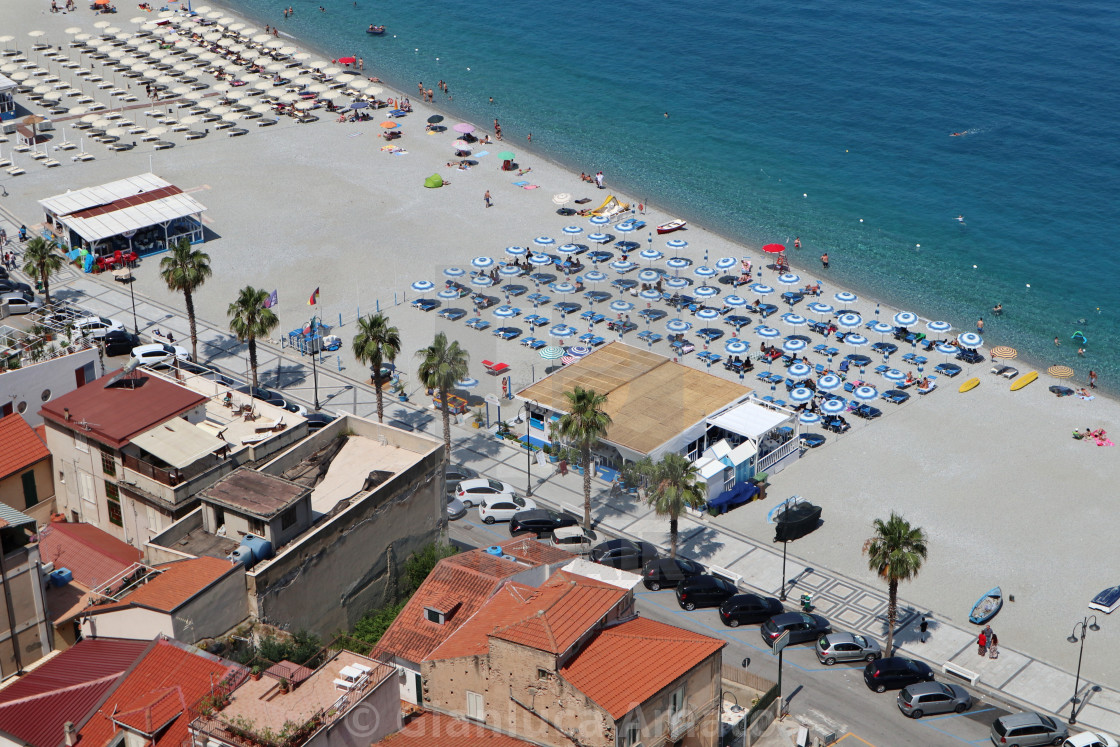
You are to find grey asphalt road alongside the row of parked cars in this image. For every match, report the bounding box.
[449,511,1014,747]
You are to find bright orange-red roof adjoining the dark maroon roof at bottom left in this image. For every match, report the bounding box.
[77,639,240,747]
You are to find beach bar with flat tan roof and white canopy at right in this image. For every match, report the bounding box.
[516,342,800,497]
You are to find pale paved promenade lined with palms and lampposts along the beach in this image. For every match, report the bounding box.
[0,204,1120,734]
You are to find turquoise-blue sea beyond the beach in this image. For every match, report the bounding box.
[230,0,1120,391]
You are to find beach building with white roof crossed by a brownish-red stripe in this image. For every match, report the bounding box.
[39,174,206,262]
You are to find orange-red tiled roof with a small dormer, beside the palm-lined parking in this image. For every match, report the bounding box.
[372,540,572,662]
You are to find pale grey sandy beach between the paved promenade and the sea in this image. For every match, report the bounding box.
[0,2,1120,684]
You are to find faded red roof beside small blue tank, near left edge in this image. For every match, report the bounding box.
[39,522,142,589]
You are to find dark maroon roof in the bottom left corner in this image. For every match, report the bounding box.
[0,638,152,747]
